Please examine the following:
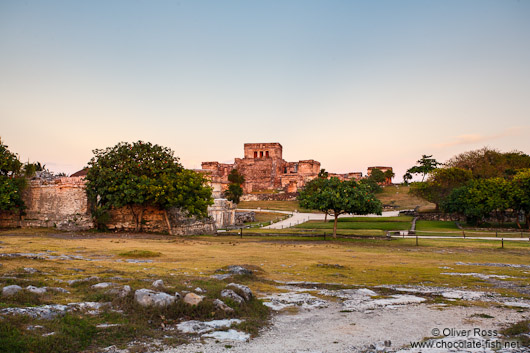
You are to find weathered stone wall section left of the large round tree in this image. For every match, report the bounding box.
[0,177,93,231]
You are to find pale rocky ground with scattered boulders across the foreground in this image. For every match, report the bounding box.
[0,238,530,353]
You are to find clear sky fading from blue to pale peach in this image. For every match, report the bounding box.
[0,0,530,181]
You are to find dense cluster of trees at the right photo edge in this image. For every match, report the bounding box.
[409,148,530,229]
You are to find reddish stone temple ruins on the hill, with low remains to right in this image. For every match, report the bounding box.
[198,143,392,201]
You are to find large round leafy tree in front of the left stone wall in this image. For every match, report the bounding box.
[86,141,213,231]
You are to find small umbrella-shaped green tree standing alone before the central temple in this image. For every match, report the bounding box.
[298,178,382,238]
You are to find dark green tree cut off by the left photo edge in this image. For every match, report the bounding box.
[0,140,26,212]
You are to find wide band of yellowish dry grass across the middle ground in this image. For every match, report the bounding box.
[0,232,530,296]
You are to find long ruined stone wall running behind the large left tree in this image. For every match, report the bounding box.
[0,176,235,235]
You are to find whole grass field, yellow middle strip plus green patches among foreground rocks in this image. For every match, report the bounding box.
[0,230,530,352]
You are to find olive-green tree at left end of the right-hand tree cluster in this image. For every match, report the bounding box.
[409,168,472,209]
